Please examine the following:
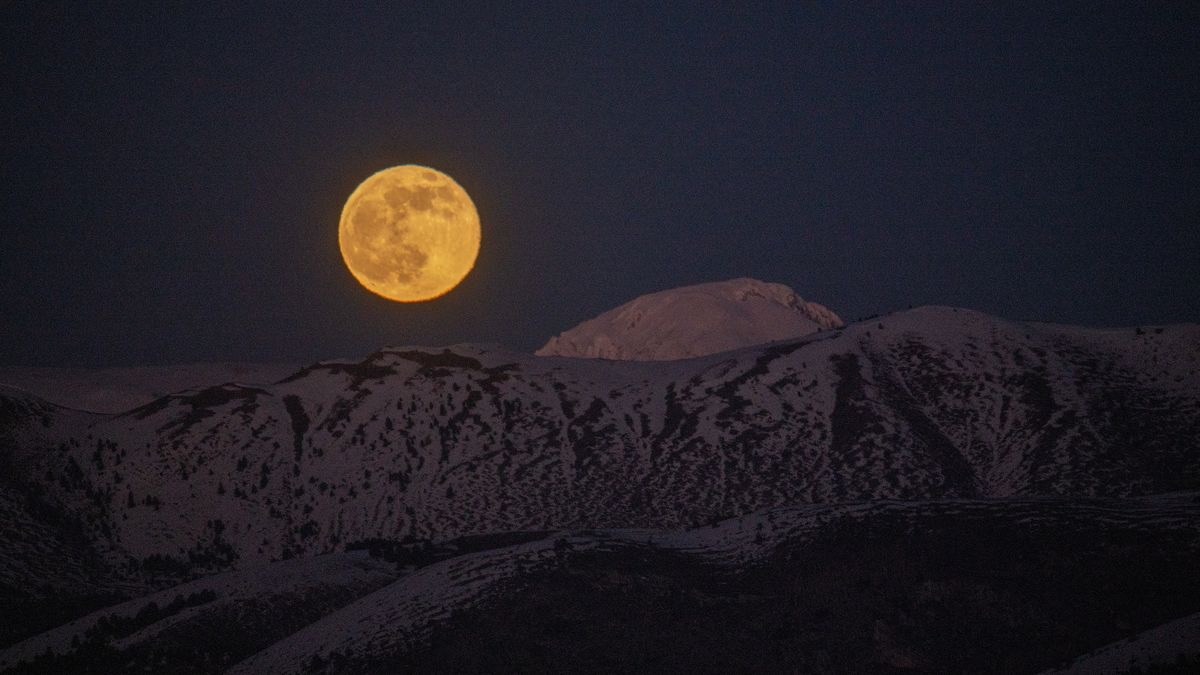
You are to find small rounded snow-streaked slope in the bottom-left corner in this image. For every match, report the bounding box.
[0,554,398,673]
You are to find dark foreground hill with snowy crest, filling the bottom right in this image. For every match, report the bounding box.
[232,494,1200,674]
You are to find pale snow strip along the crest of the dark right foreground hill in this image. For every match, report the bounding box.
[230,494,1200,674]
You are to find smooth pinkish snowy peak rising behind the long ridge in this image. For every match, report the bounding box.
[536,279,842,360]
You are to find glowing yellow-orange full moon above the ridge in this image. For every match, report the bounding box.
[337,165,479,303]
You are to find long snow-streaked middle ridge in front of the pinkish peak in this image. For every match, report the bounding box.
[0,307,1200,578]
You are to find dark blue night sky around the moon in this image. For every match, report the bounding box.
[0,1,1200,365]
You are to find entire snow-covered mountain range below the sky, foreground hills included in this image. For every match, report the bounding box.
[0,280,1200,673]
